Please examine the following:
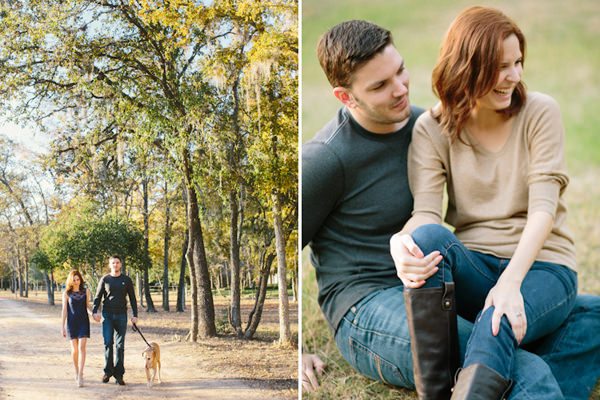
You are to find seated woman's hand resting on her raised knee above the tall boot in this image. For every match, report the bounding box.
[390,232,442,288]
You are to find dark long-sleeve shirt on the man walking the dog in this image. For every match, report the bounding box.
[92,274,137,318]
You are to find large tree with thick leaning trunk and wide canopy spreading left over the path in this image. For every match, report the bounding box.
[0,0,221,340]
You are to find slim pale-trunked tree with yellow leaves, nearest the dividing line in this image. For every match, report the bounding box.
[248,3,298,344]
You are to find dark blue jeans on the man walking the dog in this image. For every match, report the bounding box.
[102,311,127,378]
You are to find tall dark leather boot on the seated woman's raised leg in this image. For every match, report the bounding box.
[404,282,459,400]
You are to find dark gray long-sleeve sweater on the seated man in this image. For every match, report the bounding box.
[302,107,423,332]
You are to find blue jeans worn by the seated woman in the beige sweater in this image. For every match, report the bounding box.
[412,224,577,379]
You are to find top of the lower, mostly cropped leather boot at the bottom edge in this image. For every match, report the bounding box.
[452,363,513,400]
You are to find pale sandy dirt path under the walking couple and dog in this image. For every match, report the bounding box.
[0,298,290,400]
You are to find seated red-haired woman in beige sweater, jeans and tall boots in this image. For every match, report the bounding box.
[390,6,577,400]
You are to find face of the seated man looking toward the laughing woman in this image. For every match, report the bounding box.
[334,44,410,133]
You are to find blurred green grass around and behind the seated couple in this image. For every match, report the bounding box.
[302,0,600,399]
